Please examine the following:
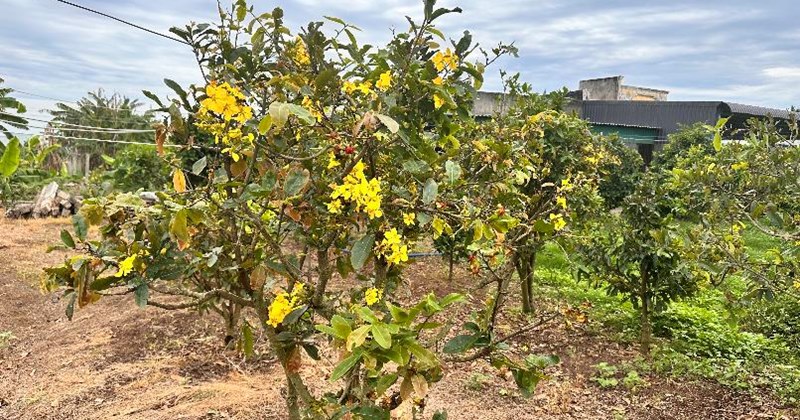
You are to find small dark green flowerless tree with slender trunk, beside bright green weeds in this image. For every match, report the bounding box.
[578,172,702,355]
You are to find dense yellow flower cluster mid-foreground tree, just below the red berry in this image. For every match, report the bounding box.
[327,160,383,219]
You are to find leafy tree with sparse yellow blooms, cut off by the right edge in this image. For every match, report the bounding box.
[670,118,800,299]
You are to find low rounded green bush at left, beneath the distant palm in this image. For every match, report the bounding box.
[95,144,170,193]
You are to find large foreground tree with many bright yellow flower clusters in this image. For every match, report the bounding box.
[45,0,574,418]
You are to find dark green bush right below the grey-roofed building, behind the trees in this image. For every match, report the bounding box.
[598,136,644,209]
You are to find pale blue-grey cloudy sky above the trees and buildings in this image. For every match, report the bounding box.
[0,0,800,131]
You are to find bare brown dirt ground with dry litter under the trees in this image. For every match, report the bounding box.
[0,216,798,420]
